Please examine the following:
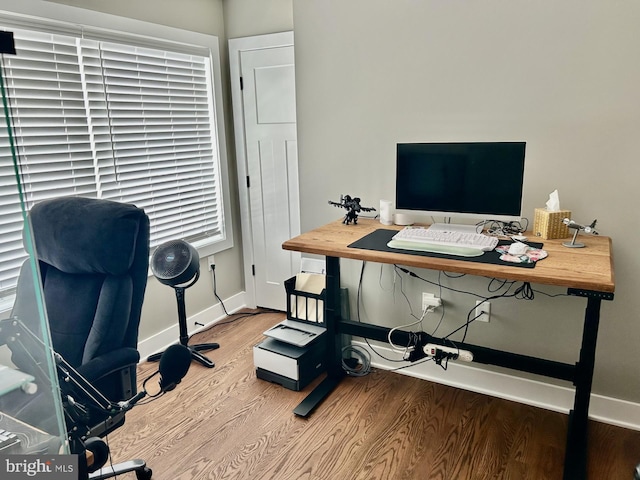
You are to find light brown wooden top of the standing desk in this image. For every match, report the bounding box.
[282,218,615,293]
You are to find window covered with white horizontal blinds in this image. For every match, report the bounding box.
[0,14,232,295]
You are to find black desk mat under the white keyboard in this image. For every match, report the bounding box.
[348,228,543,268]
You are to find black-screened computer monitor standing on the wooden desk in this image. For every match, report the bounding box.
[395,142,526,221]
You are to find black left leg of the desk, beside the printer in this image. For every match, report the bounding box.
[293,257,345,417]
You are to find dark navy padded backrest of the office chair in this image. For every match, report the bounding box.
[12,197,149,376]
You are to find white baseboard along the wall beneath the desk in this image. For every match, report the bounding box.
[352,340,640,431]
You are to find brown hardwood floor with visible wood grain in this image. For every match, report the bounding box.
[109,313,640,480]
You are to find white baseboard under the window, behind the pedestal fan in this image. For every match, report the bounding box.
[138,292,246,359]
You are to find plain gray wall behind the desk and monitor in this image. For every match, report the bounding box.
[294,0,640,402]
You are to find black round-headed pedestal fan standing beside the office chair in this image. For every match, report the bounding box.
[148,240,220,368]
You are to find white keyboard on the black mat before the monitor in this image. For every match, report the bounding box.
[393,227,498,252]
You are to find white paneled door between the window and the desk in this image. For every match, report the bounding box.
[230,32,300,310]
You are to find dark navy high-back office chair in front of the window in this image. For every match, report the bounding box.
[0,197,151,479]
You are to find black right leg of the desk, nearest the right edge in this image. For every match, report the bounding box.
[563,297,601,480]
